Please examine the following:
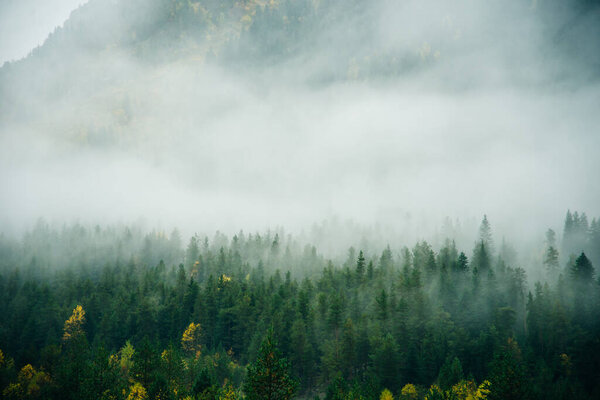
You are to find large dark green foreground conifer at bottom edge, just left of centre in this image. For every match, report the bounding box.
[244,329,298,400]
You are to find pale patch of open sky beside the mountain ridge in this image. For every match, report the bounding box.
[0,0,87,65]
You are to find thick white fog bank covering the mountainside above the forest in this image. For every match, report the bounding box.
[0,0,600,253]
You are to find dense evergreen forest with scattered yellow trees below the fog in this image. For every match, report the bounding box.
[0,211,600,400]
